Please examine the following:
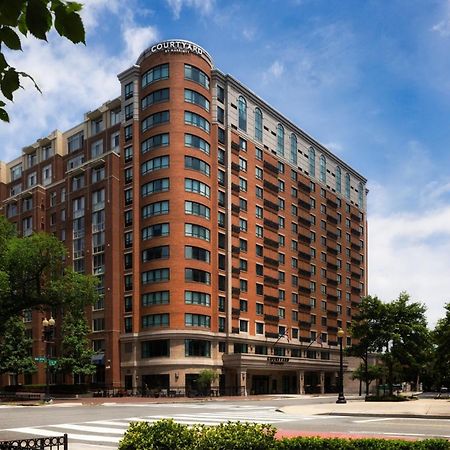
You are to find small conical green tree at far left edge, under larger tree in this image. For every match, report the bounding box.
[0,316,36,382]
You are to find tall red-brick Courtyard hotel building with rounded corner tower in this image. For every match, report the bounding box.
[0,40,367,394]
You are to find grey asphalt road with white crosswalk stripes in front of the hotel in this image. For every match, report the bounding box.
[0,397,450,450]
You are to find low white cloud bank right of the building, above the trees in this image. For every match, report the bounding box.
[368,206,450,326]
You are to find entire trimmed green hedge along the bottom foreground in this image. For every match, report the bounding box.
[119,419,450,450]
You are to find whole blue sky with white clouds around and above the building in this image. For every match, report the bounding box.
[0,0,450,324]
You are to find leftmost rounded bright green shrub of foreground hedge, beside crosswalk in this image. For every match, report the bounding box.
[119,419,196,450]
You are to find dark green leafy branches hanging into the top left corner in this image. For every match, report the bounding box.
[0,0,85,122]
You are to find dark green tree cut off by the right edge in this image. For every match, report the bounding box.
[433,303,450,387]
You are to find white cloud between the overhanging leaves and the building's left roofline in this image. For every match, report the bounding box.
[0,0,158,161]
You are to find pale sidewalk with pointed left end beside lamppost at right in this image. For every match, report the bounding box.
[279,399,450,419]
